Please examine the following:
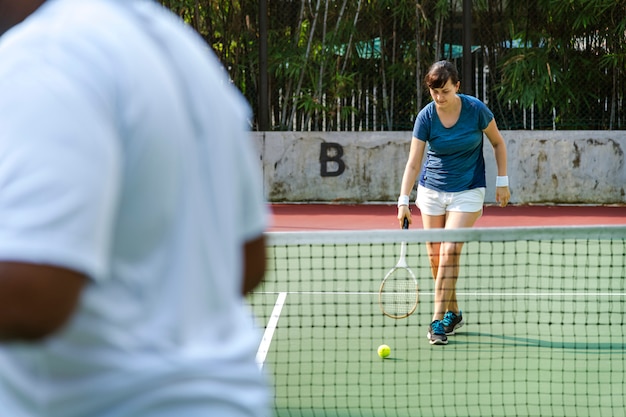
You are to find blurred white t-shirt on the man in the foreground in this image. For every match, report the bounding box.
[0,0,271,417]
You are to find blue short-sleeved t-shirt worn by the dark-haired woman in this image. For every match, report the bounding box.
[413,94,493,192]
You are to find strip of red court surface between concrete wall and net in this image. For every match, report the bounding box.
[270,204,626,232]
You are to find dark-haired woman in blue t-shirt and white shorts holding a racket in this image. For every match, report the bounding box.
[398,61,511,345]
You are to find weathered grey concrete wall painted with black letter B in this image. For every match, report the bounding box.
[254,130,626,204]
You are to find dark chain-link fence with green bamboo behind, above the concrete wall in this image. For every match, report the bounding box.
[162,0,626,131]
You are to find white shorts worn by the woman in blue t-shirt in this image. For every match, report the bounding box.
[415,185,485,216]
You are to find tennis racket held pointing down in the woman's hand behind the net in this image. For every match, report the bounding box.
[378,217,419,319]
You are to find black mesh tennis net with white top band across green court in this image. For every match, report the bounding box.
[250,226,626,417]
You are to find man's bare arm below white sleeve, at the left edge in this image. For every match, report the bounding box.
[0,262,87,341]
